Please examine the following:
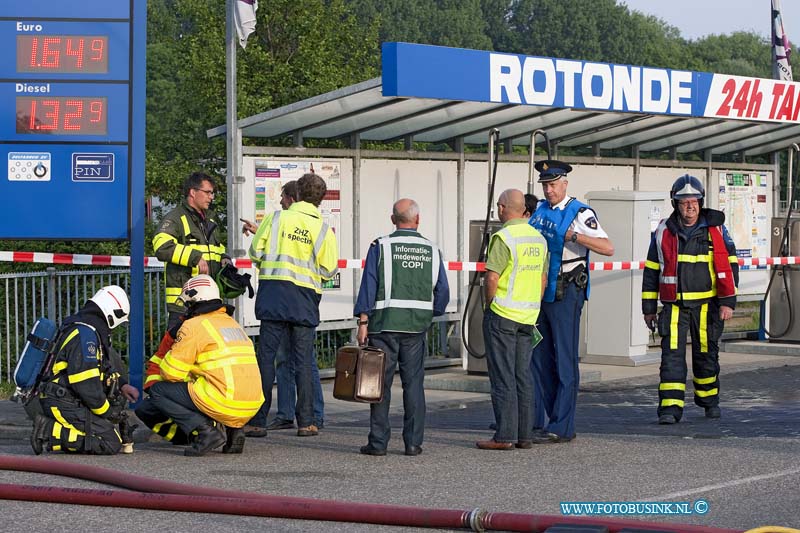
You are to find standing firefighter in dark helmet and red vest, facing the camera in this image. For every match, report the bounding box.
[642,174,739,424]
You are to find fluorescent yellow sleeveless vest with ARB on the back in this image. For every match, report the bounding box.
[491,224,547,324]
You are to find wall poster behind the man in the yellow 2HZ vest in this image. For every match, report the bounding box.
[255,159,342,289]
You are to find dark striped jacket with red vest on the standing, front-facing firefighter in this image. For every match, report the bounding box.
[642,209,739,315]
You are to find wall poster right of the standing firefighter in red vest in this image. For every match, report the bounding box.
[719,172,770,270]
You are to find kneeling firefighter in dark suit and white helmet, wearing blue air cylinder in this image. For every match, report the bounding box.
[31,285,139,455]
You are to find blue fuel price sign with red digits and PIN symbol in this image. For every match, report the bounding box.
[0,0,146,240]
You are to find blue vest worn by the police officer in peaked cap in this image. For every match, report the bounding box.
[530,198,590,302]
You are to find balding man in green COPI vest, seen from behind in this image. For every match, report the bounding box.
[353,198,450,456]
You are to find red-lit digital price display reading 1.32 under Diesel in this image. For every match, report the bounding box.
[17,96,108,135]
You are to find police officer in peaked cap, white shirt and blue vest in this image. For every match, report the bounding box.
[530,159,614,444]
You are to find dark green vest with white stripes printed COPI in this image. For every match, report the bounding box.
[368,230,441,333]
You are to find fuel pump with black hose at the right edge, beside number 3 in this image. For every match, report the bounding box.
[761,143,800,342]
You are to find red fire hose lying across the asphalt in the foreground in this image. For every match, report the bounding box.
[0,455,768,533]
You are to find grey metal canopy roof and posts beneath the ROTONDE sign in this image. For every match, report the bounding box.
[207,77,800,312]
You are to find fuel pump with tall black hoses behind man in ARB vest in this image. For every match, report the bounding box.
[461,128,550,373]
